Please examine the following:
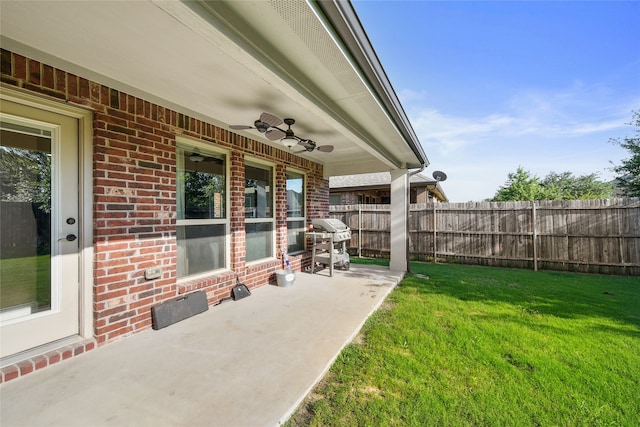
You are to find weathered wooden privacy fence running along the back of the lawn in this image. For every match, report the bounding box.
[330,198,640,276]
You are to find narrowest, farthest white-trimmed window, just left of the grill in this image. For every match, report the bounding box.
[287,171,306,253]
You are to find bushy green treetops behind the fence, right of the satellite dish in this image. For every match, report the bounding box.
[491,167,613,202]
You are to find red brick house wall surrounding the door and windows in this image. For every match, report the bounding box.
[1,50,329,344]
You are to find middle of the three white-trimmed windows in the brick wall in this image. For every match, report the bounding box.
[244,161,275,262]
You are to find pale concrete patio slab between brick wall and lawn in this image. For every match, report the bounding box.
[0,264,402,427]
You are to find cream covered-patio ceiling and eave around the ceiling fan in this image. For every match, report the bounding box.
[0,0,428,176]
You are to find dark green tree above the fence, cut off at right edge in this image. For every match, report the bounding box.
[609,110,640,197]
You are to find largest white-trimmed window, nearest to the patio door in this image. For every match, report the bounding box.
[176,143,229,279]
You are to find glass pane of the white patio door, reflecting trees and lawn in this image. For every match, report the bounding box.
[0,122,52,320]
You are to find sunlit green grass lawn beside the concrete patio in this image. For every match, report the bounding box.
[288,260,640,426]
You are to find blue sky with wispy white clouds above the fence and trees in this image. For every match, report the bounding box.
[353,0,640,202]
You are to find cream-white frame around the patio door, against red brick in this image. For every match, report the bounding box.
[0,84,94,344]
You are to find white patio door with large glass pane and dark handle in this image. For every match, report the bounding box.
[0,101,79,357]
